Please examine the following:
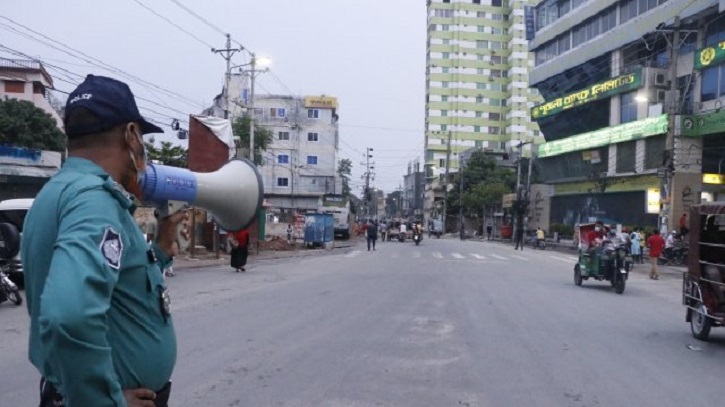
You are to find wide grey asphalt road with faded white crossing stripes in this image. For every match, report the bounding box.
[0,239,725,407]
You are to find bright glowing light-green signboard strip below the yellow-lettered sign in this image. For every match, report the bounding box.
[539,115,667,158]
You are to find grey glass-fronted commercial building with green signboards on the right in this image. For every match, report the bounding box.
[527,0,725,228]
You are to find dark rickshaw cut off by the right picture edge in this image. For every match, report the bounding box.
[682,202,725,341]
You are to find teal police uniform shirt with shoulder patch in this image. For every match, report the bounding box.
[22,158,176,407]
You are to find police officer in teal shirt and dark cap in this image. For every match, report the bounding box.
[22,75,186,407]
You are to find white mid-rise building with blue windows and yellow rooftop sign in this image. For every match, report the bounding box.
[254,95,342,214]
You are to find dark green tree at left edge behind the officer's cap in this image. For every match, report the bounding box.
[0,98,66,151]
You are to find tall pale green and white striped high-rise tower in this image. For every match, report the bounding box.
[425,0,539,220]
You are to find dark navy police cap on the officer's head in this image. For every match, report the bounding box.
[63,75,163,137]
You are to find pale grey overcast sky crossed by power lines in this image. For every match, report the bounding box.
[0,0,426,195]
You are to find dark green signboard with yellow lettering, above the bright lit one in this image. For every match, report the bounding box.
[531,70,642,120]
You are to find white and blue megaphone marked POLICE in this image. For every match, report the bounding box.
[139,158,264,232]
